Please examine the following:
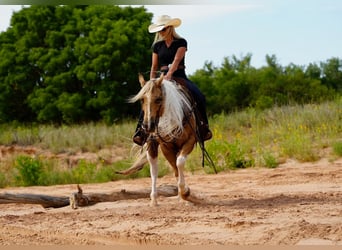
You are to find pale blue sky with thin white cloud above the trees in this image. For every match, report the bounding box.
[0,0,342,74]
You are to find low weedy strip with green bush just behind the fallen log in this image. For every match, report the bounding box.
[0,155,169,188]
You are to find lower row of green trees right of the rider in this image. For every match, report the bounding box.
[190,54,342,114]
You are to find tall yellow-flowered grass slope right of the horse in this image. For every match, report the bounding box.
[187,99,342,173]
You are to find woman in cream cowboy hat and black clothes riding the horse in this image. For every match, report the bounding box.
[133,15,212,145]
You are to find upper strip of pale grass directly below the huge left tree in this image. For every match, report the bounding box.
[0,121,136,153]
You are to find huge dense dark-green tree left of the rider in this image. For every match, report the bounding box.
[0,5,153,123]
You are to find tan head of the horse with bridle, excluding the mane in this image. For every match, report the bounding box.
[139,74,164,133]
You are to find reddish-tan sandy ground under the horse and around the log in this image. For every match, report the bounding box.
[0,159,342,246]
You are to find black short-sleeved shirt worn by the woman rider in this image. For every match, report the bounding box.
[152,38,188,67]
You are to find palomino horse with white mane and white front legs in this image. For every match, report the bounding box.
[130,75,197,205]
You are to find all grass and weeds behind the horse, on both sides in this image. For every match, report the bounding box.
[0,98,342,187]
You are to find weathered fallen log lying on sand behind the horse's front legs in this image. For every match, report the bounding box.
[0,185,178,209]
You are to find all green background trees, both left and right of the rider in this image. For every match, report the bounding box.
[0,5,342,124]
